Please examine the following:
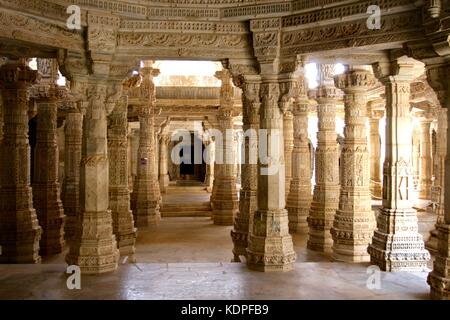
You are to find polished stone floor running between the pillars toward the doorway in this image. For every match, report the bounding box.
[0,187,434,300]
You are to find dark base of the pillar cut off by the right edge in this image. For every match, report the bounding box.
[427,224,450,300]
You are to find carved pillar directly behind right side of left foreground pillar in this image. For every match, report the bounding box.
[108,88,137,261]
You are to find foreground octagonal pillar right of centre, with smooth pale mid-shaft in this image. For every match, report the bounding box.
[247,76,297,271]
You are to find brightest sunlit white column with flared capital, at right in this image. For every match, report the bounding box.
[368,57,430,271]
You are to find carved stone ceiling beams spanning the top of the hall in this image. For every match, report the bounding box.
[0,0,440,68]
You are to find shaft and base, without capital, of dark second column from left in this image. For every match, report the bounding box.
[33,98,65,255]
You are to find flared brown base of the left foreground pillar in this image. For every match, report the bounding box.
[66,210,119,274]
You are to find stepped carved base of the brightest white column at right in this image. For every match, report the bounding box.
[367,209,431,272]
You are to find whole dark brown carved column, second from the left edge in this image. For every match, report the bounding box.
[32,59,65,255]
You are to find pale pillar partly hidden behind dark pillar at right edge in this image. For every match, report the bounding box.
[426,108,448,254]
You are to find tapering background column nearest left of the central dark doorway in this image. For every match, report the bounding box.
[132,66,161,228]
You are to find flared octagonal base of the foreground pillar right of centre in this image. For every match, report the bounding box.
[247,210,297,272]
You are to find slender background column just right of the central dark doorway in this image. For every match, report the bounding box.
[212,69,239,225]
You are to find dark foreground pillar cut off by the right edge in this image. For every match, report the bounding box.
[427,64,450,300]
